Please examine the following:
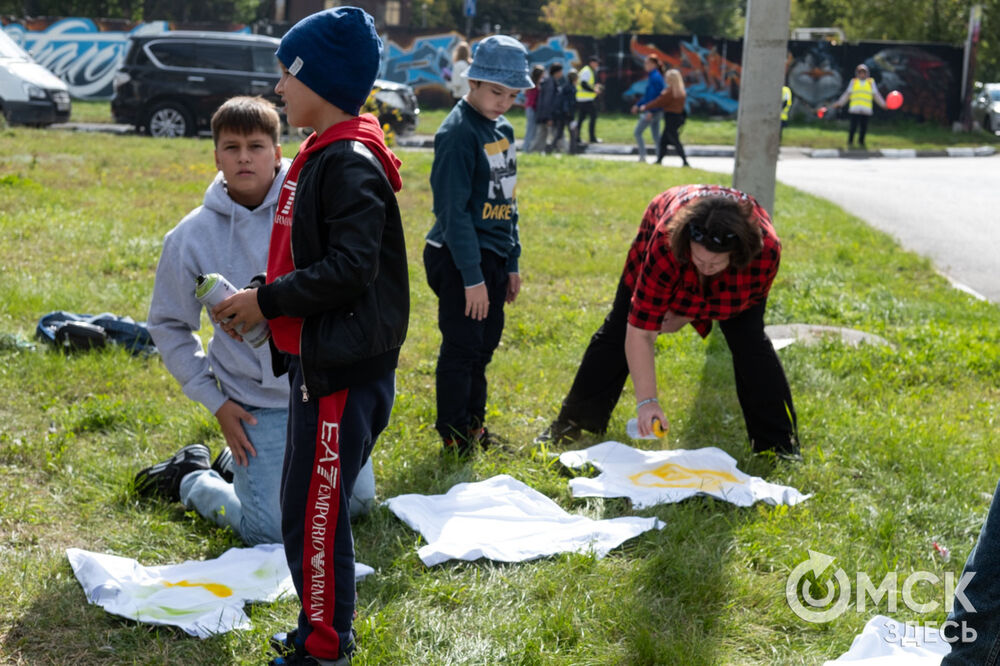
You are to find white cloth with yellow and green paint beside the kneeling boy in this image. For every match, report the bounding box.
[66,544,373,638]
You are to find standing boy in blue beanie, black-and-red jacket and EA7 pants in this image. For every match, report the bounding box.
[212,7,409,666]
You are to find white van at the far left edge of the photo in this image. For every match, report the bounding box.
[0,30,71,127]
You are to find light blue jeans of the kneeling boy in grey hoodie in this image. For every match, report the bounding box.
[180,407,375,546]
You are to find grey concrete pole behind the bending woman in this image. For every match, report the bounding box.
[733,0,791,213]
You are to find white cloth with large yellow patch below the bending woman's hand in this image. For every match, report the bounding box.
[559,442,810,509]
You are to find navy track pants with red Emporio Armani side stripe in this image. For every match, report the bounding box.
[281,356,395,659]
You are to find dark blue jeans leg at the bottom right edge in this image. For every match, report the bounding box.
[941,485,1000,666]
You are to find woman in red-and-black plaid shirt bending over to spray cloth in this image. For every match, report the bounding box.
[538,185,799,458]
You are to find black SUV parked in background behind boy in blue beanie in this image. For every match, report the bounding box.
[111,31,420,137]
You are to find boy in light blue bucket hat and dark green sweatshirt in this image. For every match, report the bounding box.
[424,35,534,455]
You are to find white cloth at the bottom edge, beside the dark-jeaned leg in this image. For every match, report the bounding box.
[823,615,951,666]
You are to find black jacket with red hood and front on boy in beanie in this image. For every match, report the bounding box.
[257,116,410,397]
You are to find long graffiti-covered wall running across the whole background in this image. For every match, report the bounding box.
[3,18,962,123]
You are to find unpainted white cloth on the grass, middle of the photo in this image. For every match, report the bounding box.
[385,474,665,566]
